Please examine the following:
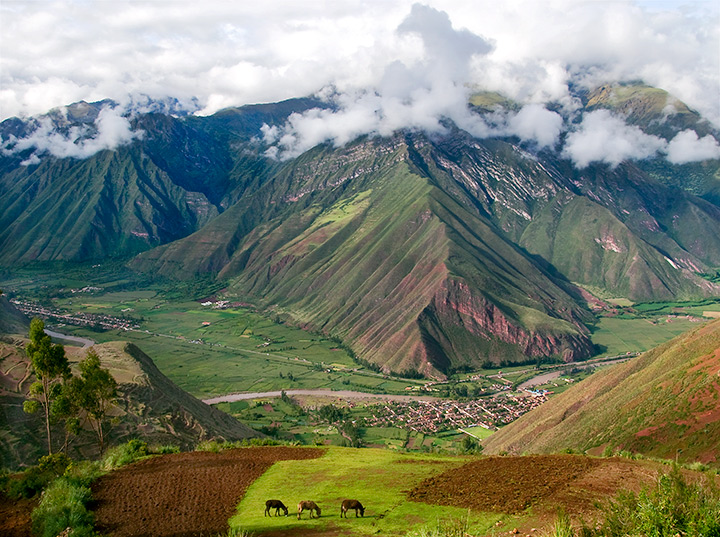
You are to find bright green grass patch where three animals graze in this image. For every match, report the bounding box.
[229,447,502,537]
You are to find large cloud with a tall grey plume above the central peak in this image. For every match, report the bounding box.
[264,4,492,158]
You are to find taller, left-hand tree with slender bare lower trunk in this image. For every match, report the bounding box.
[23,318,70,455]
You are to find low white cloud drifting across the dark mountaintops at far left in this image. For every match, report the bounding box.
[2,106,143,165]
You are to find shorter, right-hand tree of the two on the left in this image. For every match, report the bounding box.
[71,348,117,453]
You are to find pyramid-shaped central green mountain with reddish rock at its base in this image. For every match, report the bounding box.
[133,136,591,374]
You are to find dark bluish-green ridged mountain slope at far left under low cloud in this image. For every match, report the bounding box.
[0,147,217,265]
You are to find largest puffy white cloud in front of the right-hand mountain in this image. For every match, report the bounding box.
[563,110,667,168]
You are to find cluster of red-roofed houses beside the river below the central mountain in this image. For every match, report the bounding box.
[364,392,547,434]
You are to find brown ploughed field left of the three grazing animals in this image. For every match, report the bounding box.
[92,447,324,537]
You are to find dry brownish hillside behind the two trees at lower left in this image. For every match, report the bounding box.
[0,341,258,468]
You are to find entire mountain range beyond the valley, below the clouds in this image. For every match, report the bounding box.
[0,88,720,375]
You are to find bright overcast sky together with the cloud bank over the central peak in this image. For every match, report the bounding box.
[0,0,720,165]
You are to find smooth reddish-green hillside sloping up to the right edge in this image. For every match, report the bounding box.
[484,321,720,464]
